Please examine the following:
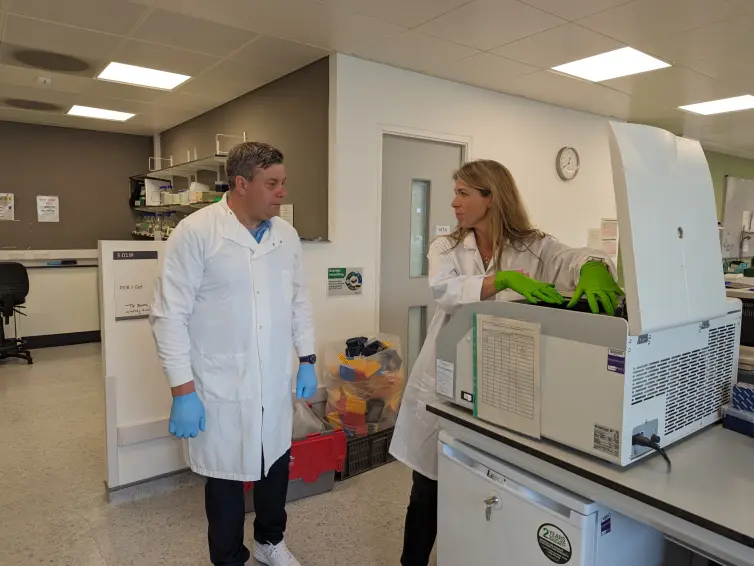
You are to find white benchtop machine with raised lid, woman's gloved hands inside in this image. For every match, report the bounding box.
[436,123,741,466]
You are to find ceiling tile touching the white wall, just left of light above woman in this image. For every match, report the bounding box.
[432,53,539,92]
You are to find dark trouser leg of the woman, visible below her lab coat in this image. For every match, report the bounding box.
[401,472,437,566]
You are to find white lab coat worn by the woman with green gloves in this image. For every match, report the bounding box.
[390,232,615,480]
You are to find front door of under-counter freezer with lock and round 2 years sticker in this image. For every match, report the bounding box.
[437,454,593,566]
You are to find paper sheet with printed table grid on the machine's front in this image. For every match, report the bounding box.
[474,315,541,438]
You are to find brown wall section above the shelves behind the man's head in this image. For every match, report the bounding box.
[160,58,330,239]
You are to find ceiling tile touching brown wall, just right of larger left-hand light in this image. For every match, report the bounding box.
[176,59,285,102]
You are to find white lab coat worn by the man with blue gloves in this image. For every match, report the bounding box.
[151,198,314,481]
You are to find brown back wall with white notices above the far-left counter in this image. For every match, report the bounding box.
[0,122,152,250]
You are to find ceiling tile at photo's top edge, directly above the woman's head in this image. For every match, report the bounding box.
[416,0,565,51]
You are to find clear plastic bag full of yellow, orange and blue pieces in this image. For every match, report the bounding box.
[323,334,405,437]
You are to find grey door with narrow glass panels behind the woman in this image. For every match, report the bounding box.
[379,135,464,375]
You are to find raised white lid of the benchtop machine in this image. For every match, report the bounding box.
[609,122,728,336]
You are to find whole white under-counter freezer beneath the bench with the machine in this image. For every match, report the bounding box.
[437,432,665,566]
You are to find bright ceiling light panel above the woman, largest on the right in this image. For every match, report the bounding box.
[552,47,670,83]
